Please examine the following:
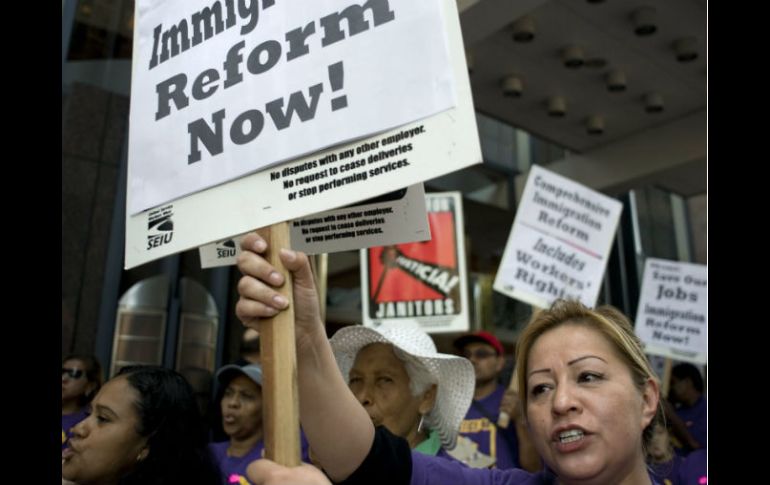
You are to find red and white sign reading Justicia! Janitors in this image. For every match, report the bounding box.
[361,192,470,333]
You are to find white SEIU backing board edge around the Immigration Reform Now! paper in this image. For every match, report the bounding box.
[125,0,481,268]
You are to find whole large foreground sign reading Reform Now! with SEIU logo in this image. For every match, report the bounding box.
[125,0,481,269]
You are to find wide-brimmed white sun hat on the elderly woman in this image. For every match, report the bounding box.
[330,322,476,450]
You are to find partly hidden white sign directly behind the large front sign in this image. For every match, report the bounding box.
[200,184,430,268]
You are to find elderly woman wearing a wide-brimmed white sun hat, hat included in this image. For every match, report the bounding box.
[331,322,475,457]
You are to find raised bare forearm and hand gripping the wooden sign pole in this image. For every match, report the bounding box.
[235,233,374,481]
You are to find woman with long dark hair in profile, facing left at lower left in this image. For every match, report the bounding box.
[62,366,219,485]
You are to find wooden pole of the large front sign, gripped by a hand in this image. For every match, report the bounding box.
[258,222,300,466]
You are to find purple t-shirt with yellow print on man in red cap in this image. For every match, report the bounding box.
[460,385,519,469]
